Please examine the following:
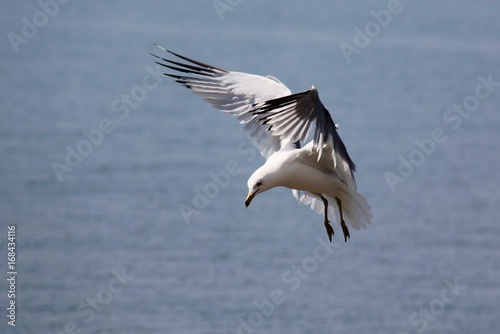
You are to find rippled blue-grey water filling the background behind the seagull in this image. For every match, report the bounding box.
[0,0,500,334]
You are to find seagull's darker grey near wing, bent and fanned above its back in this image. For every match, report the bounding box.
[252,86,356,175]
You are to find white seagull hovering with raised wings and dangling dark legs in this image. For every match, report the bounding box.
[150,44,372,242]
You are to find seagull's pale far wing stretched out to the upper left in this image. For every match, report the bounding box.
[151,45,291,158]
